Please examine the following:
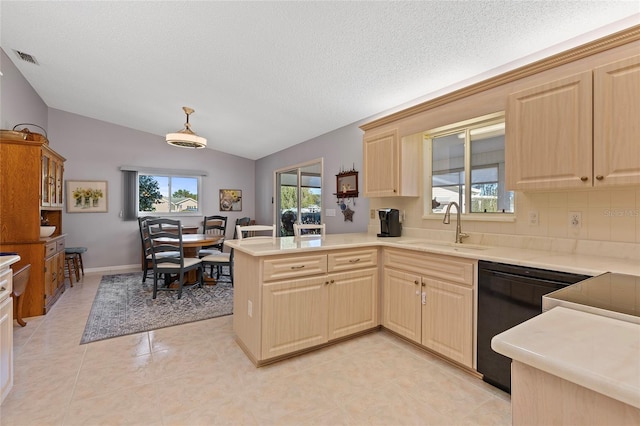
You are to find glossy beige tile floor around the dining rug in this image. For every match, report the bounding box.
[0,271,511,426]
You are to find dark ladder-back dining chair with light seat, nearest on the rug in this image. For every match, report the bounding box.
[143,218,204,299]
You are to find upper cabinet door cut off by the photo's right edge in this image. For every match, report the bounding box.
[593,55,640,186]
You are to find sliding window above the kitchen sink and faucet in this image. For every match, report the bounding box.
[424,113,514,217]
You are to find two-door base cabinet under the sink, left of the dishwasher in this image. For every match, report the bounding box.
[382,250,475,368]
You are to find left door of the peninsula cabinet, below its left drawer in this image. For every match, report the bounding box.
[262,276,329,359]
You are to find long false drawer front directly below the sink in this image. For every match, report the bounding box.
[384,249,475,285]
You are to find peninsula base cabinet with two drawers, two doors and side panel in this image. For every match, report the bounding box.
[234,248,379,364]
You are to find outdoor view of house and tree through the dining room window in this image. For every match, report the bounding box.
[138,173,200,214]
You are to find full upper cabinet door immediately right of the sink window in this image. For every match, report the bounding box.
[505,71,593,190]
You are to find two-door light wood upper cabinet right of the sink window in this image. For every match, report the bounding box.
[506,56,640,190]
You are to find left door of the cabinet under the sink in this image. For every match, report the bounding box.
[382,268,422,343]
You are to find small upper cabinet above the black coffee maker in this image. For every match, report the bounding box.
[363,130,422,197]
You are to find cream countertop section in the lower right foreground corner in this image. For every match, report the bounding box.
[491,306,640,408]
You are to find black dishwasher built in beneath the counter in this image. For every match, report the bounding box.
[478,261,590,393]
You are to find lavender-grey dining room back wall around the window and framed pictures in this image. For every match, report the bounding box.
[49,109,255,268]
